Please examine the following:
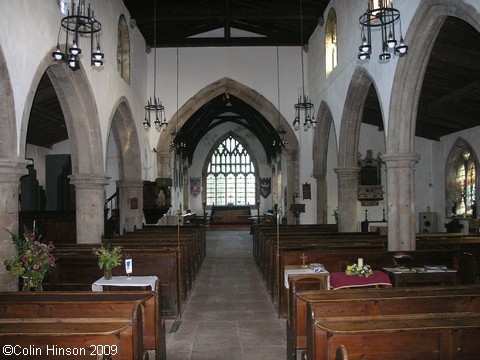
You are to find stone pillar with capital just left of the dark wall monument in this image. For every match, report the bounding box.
[334,167,360,232]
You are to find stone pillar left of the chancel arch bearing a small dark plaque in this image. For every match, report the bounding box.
[117,180,143,233]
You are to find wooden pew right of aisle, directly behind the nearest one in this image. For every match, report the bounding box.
[287,284,480,359]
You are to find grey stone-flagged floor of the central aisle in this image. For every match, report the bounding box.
[166,230,286,360]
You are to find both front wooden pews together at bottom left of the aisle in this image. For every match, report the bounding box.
[0,281,166,360]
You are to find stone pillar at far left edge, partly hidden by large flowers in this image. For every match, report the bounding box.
[0,160,28,291]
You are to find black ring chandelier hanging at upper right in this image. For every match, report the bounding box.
[358,0,408,62]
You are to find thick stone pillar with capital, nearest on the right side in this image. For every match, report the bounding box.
[381,153,419,251]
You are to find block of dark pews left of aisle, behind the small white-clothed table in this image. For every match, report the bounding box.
[43,226,206,317]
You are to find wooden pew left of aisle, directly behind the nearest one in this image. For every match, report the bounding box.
[0,285,166,360]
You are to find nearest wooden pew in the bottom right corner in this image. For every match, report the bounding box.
[308,313,480,360]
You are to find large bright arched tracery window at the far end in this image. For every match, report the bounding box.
[206,135,256,205]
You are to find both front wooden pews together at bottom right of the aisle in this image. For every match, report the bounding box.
[287,285,480,360]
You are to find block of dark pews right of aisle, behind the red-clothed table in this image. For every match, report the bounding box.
[253,225,462,317]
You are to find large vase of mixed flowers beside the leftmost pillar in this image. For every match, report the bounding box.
[4,227,55,291]
